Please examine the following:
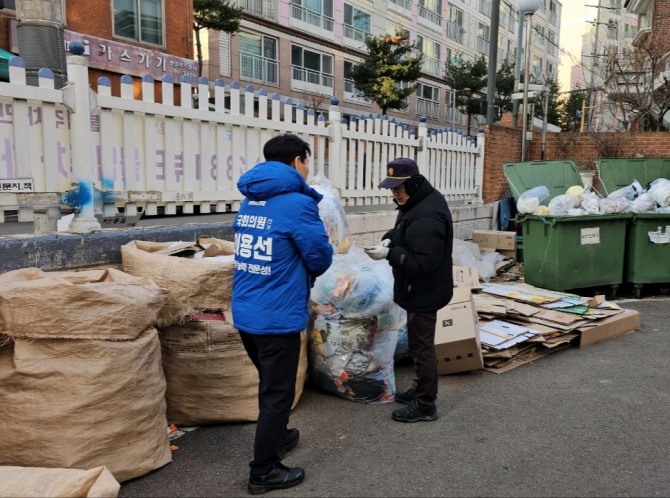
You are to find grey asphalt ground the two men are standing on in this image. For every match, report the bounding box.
[120,296,670,497]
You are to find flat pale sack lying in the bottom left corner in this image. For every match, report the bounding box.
[0,467,121,498]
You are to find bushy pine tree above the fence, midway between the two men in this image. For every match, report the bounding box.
[351,32,423,114]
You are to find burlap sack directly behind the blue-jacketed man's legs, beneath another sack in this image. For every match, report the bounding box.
[160,315,307,425]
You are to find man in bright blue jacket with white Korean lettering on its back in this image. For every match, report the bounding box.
[232,134,333,494]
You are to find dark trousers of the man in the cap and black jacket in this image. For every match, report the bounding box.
[407,311,437,408]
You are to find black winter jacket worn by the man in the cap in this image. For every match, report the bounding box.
[383,177,454,313]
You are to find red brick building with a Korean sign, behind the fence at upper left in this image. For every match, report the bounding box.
[0,0,198,98]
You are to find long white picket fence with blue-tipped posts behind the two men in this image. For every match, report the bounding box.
[0,49,484,229]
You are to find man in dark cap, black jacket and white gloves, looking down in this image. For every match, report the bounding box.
[365,158,454,422]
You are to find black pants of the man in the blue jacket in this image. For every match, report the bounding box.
[240,332,300,476]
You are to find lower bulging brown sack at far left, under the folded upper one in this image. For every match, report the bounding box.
[0,326,171,481]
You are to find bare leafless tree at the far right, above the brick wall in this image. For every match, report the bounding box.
[601,34,670,131]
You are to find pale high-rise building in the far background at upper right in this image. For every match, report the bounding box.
[570,0,638,131]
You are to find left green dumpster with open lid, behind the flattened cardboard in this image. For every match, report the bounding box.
[503,161,631,296]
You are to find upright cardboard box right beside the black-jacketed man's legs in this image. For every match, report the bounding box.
[435,287,484,375]
